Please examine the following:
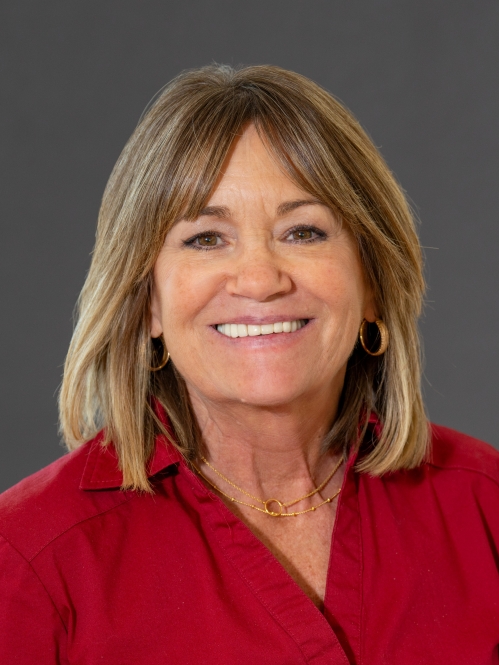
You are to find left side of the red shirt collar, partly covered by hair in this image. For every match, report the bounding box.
[80,401,182,490]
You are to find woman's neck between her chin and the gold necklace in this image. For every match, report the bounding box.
[190,384,339,500]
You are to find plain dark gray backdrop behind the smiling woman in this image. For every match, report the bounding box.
[0,0,499,490]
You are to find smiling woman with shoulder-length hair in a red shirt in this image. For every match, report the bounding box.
[0,66,499,665]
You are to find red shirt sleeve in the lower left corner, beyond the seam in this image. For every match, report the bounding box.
[0,537,68,665]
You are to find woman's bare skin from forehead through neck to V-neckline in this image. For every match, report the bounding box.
[151,125,376,608]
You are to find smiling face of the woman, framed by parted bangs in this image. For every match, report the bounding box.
[151,125,375,407]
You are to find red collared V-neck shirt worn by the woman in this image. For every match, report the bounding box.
[0,418,499,665]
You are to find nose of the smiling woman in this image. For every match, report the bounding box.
[226,247,293,302]
